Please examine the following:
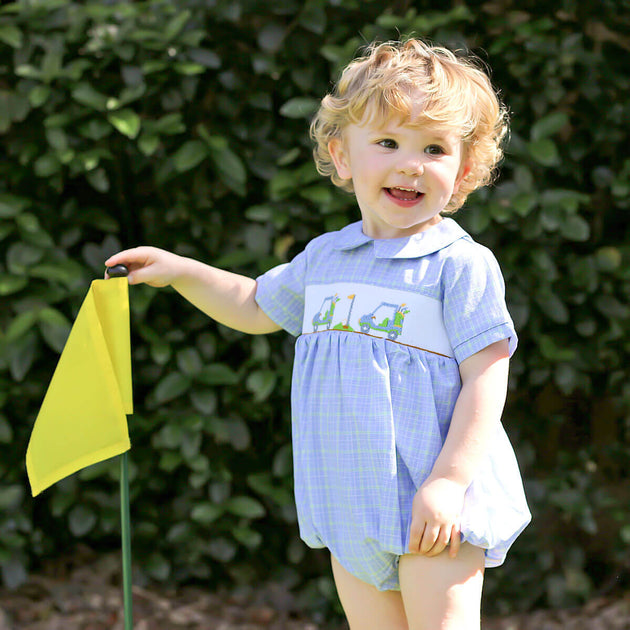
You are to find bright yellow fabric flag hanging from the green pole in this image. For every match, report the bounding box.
[26,278,133,496]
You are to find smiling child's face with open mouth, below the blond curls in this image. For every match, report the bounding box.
[329,111,469,238]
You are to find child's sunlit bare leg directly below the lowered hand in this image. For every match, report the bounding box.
[398,543,484,630]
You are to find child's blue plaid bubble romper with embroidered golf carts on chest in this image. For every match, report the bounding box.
[256,219,531,590]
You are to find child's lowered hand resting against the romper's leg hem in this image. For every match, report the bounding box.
[409,477,466,558]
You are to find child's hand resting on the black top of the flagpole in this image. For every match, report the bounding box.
[105,247,182,287]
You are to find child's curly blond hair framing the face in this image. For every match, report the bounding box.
[310,39,508,212]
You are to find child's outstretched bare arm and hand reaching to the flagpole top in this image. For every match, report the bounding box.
[105,247,280,334]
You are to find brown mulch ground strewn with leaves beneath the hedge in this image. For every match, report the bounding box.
[0,555,630,630]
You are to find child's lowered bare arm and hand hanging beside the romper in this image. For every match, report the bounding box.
[409,339,509,558]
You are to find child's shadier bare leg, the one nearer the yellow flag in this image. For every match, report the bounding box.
[331,556,407,630]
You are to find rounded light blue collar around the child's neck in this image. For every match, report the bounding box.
[333,219,470,258]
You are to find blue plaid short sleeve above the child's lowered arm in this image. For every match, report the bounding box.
[443,243,518,363]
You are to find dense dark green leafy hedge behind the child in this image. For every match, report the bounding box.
[0,0,630,624]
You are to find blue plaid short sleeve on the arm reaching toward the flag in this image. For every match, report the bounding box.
[255,252,306,337]
